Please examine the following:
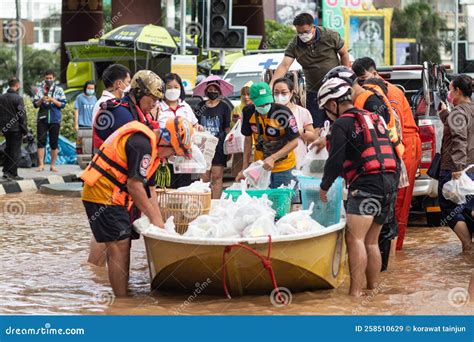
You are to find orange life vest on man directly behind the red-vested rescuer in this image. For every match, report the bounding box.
[354,84,405,158]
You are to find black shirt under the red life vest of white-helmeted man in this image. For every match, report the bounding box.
[321,109,397,194]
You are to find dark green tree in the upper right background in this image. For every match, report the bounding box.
[391,1,446,63]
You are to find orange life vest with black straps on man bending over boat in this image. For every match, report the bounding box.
[81,121,160,209]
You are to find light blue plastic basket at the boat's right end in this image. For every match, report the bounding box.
[298,177,342,227]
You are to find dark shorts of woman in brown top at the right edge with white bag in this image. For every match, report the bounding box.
[438,170,474,235]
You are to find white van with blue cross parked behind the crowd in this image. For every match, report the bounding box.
[224,52,302,105]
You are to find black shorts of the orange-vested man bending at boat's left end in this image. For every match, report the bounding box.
[82,201,140,242]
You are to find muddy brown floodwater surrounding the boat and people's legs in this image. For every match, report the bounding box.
[0,194,474,315]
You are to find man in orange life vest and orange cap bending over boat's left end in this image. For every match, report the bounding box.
[81,117,193,296]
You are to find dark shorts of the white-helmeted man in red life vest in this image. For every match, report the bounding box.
[347,189,395,224]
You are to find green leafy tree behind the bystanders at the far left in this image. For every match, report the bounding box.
[0,44,59,95]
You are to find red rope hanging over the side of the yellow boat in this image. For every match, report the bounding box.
[222,235,285,304]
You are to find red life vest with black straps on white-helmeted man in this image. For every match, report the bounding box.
[341,108,397,184]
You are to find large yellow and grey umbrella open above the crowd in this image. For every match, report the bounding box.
[99,24,177,54]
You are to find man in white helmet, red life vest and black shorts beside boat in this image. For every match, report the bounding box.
[318,78,397,296]
